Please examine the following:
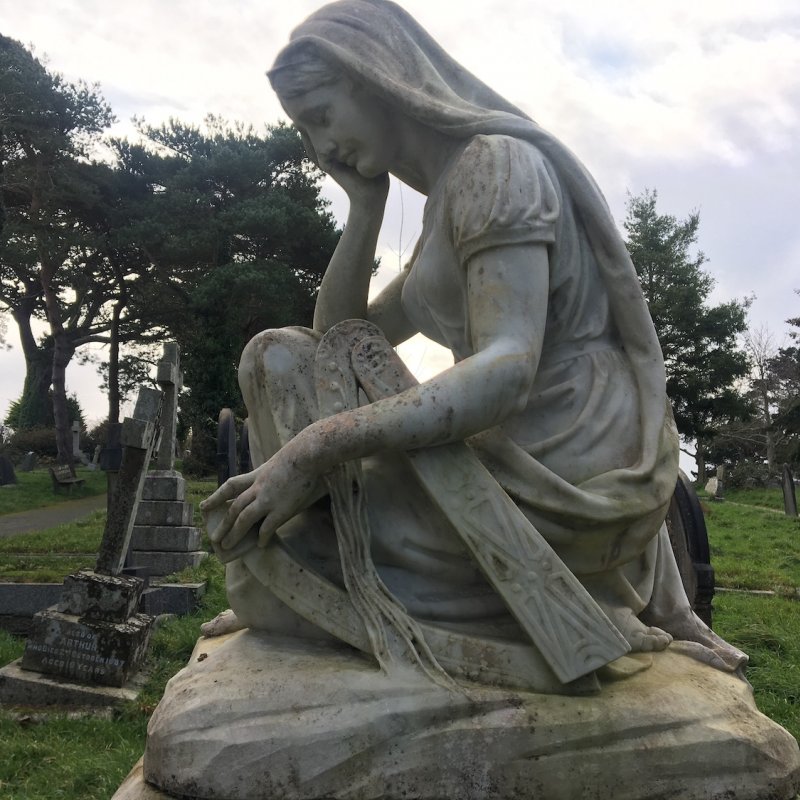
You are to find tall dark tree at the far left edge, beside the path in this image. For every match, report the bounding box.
[0,36,113,464]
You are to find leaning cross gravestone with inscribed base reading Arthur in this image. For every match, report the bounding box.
[0,388,161,705]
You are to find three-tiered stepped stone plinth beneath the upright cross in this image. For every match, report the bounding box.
[129,469,207,575]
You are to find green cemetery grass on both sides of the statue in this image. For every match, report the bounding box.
[0,482,800,800]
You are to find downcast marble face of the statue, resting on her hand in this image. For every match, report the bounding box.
[282,79,397,178]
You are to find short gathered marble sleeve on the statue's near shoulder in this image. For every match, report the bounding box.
[443,136,561,264]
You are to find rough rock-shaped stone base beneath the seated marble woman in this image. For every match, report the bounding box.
[114,631,800,800]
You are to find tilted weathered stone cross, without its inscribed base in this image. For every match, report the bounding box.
[95,387,162,575]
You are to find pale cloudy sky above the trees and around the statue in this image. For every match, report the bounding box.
[0,0,800,432]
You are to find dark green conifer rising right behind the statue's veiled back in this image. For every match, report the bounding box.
[624,191,750,479]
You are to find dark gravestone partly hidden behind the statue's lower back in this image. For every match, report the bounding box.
[666,470,714,627]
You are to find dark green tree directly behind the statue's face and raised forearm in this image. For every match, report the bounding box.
[114,117,338,469]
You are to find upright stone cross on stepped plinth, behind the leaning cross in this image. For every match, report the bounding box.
[128,342,208,575]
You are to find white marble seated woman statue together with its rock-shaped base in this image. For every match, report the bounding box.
[120,0,800,800]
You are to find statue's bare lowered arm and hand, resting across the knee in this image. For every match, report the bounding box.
[204,244,549,549]
